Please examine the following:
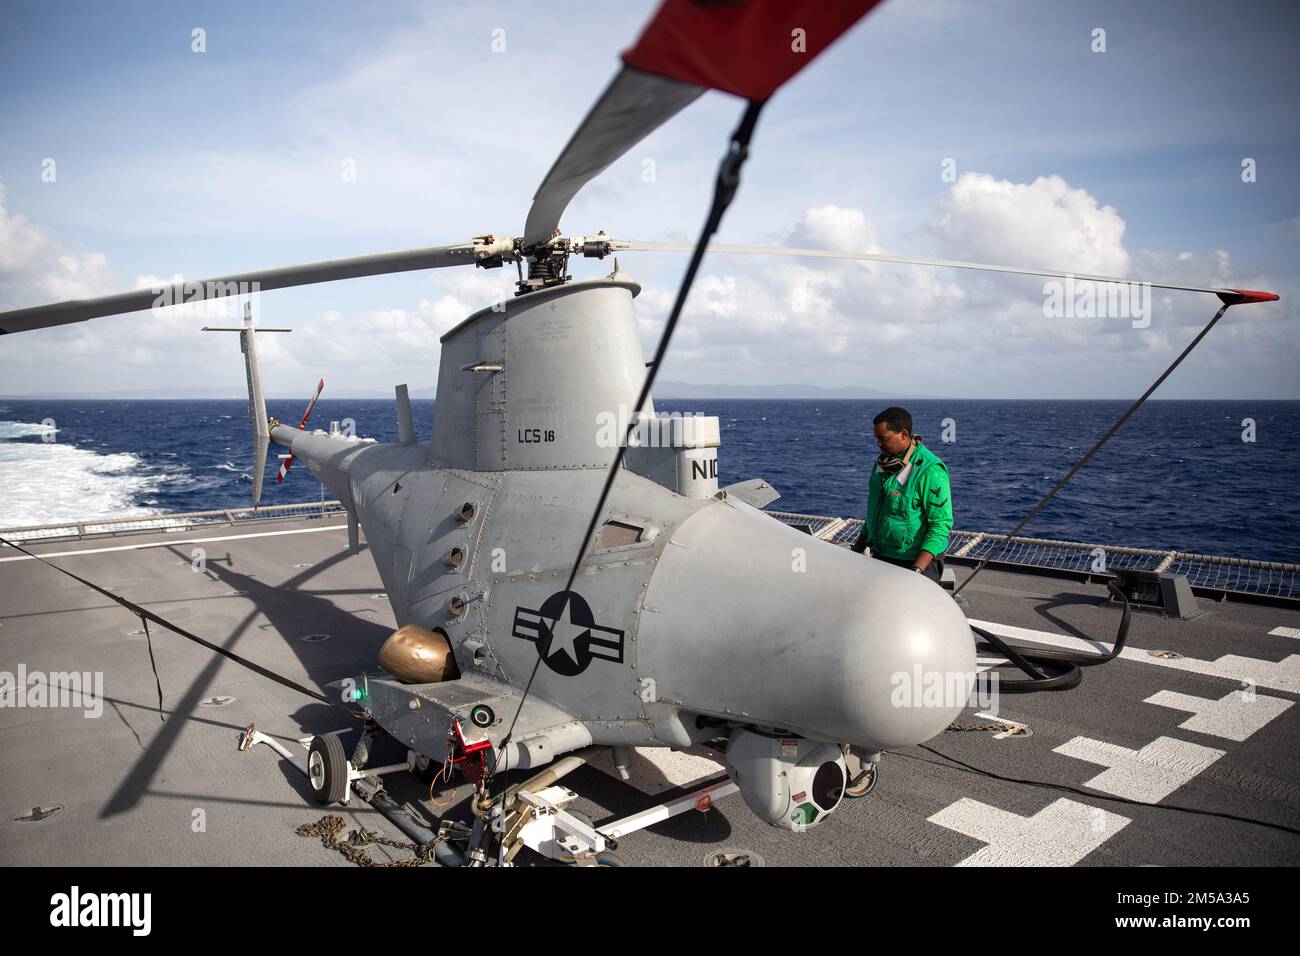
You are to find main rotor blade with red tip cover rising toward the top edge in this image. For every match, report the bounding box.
[524,0,879,250]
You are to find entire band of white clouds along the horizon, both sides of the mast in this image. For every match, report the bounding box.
[0,166,1290,394]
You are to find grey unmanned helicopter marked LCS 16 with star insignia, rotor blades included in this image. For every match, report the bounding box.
[0,0,1277,858]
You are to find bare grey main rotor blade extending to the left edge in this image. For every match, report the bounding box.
[0,242,484,334]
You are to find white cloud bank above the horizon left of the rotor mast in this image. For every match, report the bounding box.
[0,179,512,394]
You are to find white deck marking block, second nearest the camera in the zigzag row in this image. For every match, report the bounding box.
[1054,737,1223,804]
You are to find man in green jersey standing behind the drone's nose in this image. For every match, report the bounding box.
[853,406,953,581]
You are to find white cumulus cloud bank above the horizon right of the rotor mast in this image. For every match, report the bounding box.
[641,173,1286,395]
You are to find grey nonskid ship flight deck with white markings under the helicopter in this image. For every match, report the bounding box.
[0,516,1300,866]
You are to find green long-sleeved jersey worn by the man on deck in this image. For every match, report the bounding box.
[863,442,953,561]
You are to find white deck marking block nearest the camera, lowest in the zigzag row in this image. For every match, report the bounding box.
[930,797,1131,866]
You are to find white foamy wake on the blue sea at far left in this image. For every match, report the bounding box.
[0,421,161,528]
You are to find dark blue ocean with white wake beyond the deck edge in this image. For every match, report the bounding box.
[0,398,1300,563]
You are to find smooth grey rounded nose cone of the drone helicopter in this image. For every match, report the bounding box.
[637,502,975,749]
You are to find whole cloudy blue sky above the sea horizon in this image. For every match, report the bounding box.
[0,0,1300,398]
